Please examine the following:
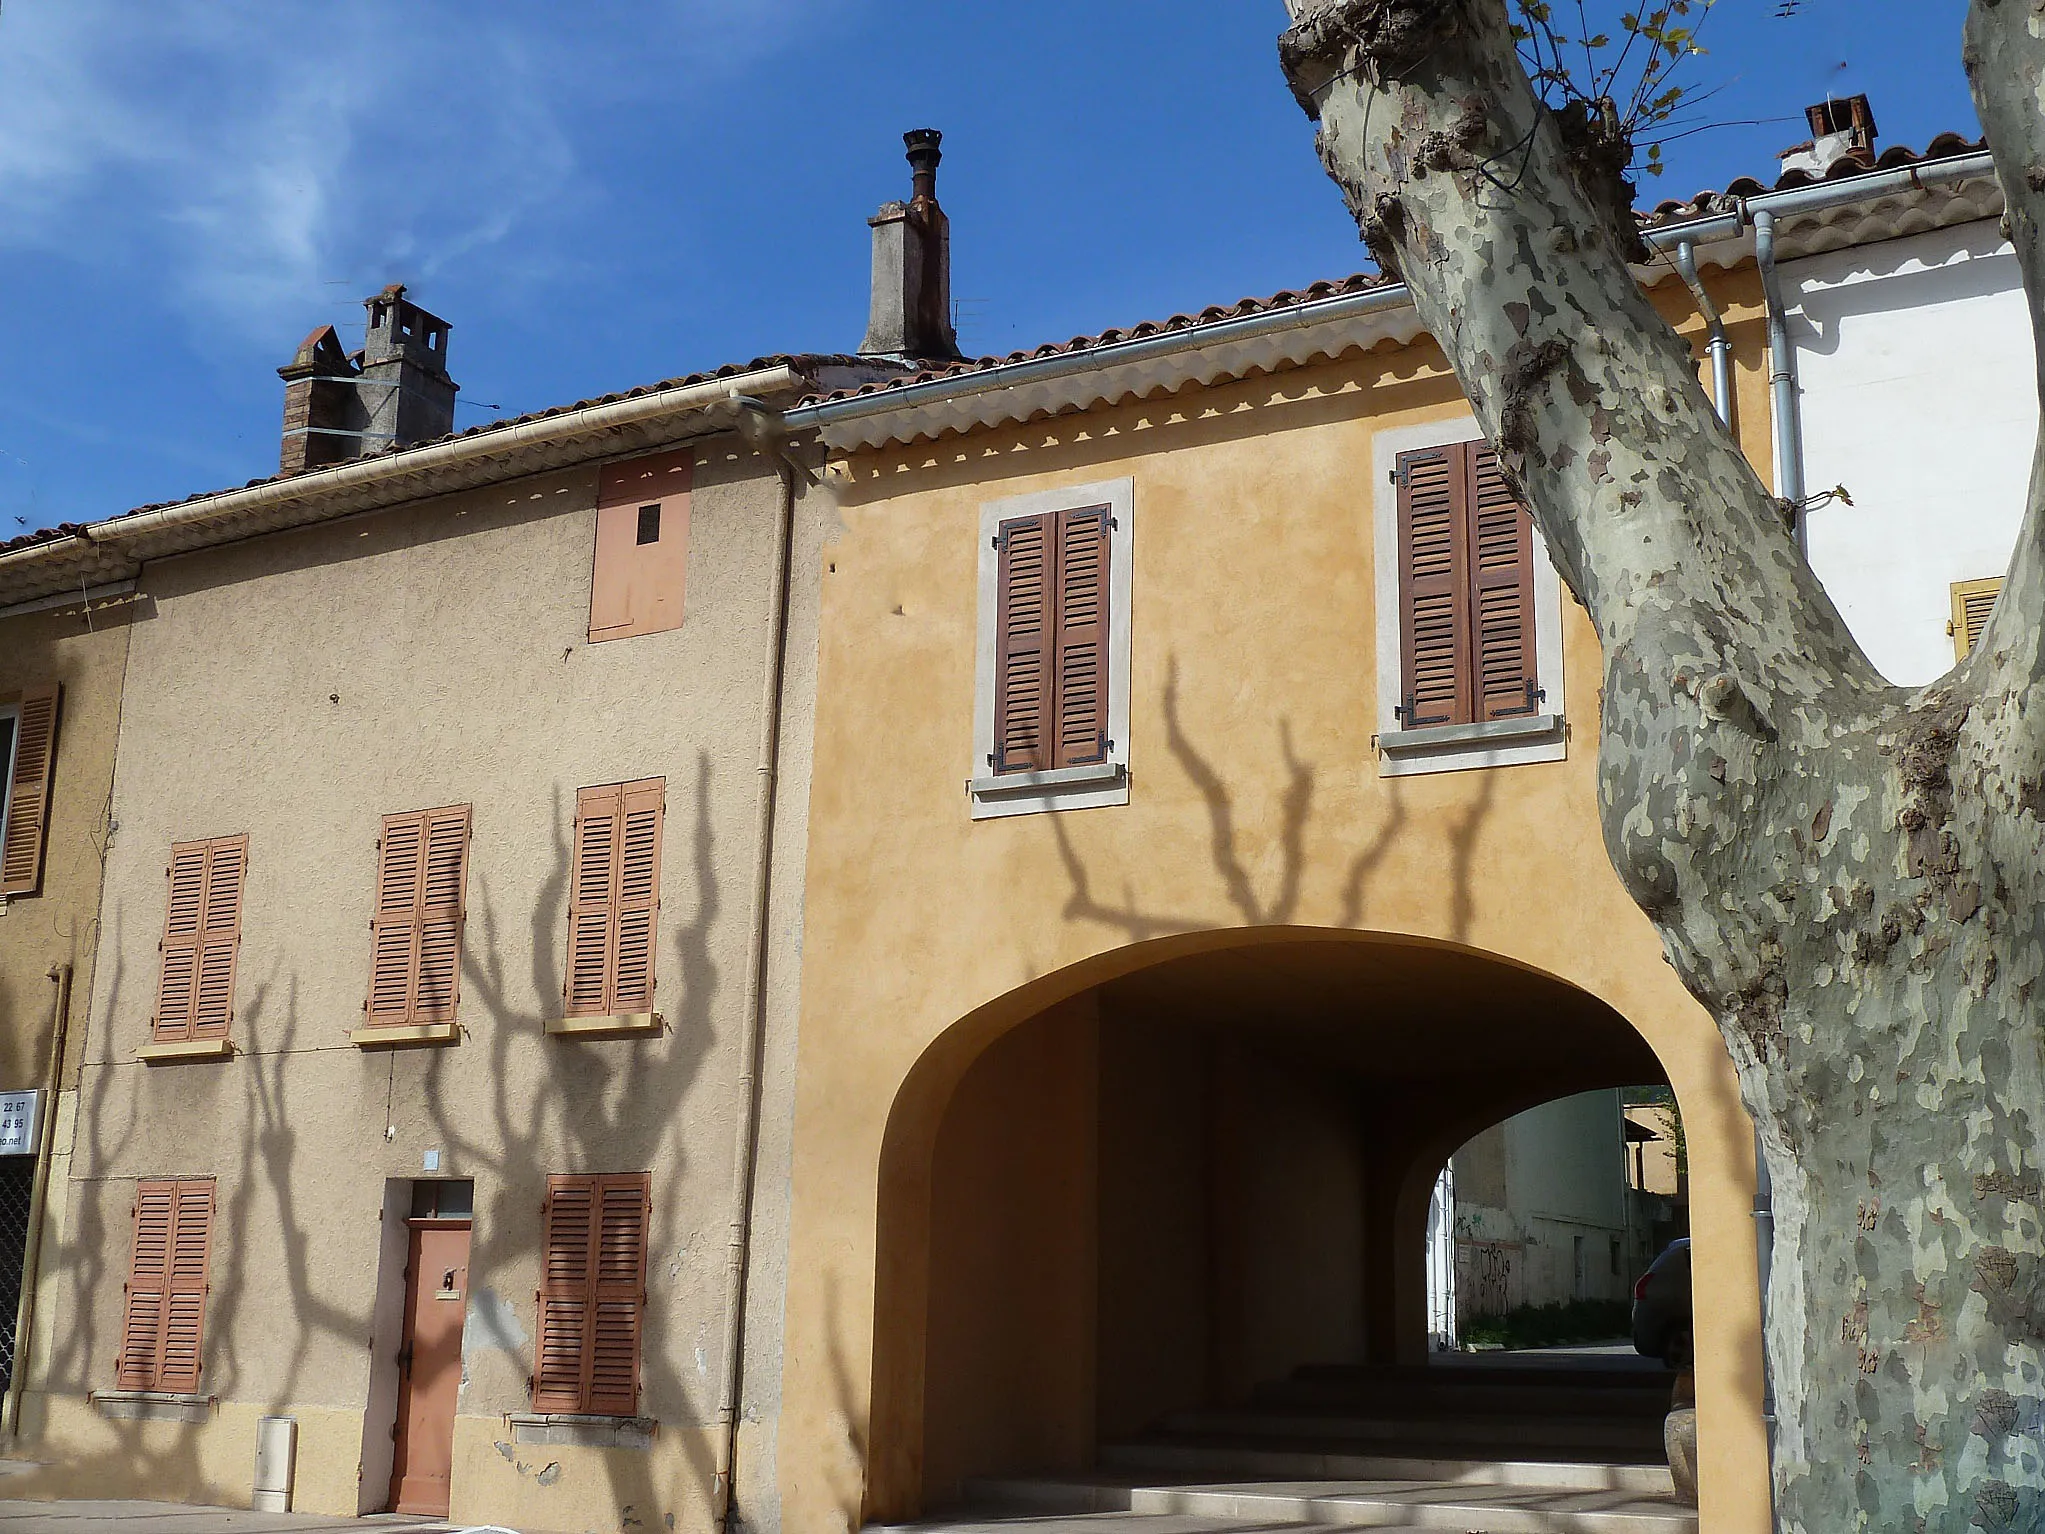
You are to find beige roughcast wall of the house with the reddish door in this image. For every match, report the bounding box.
[10,440,826,1530]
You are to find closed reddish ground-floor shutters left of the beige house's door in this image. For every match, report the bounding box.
[115,1178,213,1393]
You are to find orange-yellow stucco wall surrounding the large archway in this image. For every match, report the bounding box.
[779,278,1767,1534]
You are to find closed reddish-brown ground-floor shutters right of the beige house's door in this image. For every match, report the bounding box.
[532,1172,652,1417]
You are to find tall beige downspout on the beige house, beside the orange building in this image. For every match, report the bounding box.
[714,395,798,1530]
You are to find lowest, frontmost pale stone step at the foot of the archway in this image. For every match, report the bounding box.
[955,1477,1697,1534]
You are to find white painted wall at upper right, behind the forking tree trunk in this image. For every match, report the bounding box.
[1781,219,2037,685]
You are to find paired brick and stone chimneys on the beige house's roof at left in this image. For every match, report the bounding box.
[276,282,456,475]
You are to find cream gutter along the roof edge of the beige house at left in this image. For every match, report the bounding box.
[0,362,808,589]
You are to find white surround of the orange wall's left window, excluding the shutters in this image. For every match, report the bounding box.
[965,479,1135,820]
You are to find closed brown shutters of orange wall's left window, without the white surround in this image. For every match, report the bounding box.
[992,505,1112,773]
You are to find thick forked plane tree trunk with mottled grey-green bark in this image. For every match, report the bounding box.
[1280,0,2045,1534]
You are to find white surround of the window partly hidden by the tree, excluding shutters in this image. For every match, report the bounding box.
[1370,413,1569,777]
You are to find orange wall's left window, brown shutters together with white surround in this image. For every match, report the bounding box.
[967,479,1133,818]
